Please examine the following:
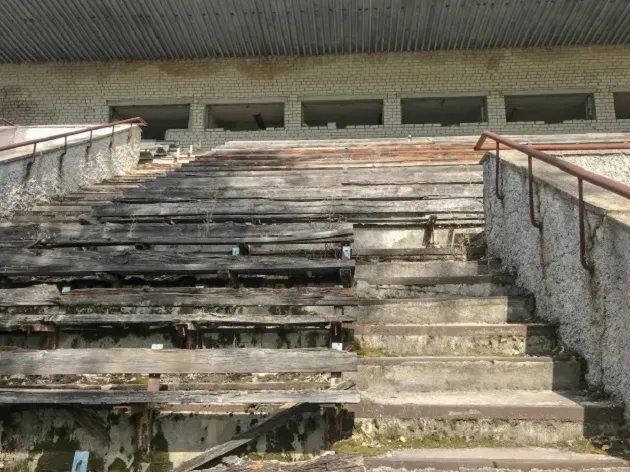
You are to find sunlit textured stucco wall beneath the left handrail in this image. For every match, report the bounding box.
[0,126,140,220]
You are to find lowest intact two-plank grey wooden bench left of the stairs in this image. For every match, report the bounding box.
[0,349,359,405]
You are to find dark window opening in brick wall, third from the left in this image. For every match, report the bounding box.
[302,100,383,129]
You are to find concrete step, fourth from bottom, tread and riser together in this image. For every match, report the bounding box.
[352,324,556,356]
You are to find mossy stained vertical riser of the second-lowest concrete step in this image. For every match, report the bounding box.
[355,415,621,446]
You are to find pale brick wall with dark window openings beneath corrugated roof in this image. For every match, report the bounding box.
[0,47,630,149]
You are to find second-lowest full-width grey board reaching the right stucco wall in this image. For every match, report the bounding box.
[118,184,483,203]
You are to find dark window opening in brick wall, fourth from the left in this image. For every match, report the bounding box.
[400,97,487,126]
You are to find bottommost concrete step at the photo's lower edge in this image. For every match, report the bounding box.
[364,447,630,472]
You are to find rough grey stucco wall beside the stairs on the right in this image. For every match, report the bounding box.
[484,152,630,416]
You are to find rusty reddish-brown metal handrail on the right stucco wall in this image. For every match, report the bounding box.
[475,131,630,271]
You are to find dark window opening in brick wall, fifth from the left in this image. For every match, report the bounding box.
[505,93,595,124]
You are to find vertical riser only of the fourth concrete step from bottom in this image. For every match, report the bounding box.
[355,334,555,356]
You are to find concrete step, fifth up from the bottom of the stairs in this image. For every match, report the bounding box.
[344,296,532,324]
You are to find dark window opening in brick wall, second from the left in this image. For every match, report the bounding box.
[206,103,284,131]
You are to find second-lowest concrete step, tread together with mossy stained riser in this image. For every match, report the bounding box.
[347,390,624,445]
